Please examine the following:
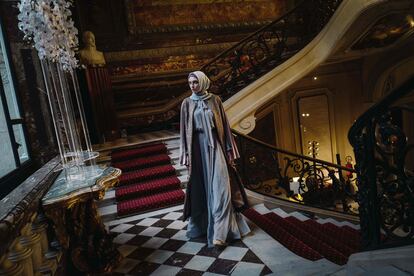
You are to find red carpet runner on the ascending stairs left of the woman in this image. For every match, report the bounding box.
[112,144,184,216]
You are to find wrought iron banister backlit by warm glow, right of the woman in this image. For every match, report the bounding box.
[233,130,357,214]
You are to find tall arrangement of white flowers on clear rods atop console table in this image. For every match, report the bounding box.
[18,0,104,186]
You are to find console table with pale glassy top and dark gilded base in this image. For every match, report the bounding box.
[42,166,121,274]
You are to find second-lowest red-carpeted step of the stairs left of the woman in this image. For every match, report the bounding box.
[115,176,181,202]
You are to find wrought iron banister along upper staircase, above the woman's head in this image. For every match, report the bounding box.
[201,0,342,100]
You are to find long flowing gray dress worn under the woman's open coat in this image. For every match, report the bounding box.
[187,100,250,247]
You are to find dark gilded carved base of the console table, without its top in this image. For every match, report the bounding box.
[43,169,121,275]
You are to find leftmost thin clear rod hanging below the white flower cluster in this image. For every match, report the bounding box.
[40,59,66,167]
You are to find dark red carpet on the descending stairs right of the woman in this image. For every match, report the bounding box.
[244,208,360,265]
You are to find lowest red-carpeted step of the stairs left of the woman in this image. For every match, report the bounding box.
[117,190,185,216]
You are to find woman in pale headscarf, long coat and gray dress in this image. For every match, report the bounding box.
[180,71,250,247]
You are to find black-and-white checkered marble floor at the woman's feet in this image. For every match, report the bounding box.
[107,206,272,275]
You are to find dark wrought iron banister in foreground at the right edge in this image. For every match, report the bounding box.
[348,77,414,249]
